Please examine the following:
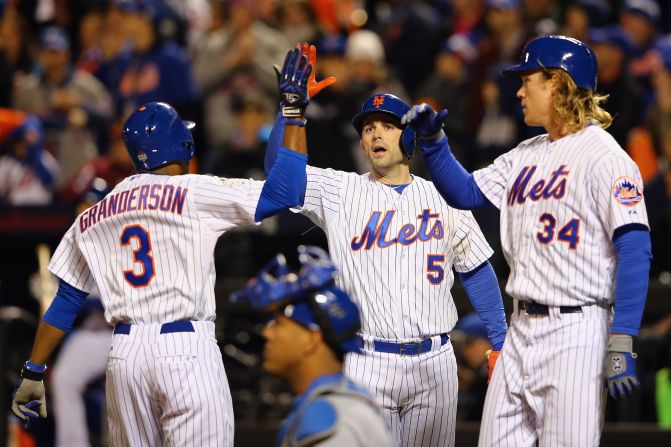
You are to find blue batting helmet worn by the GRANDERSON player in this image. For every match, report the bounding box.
[123,102,195,172]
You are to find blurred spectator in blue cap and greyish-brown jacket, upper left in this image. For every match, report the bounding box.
[13,26,112,181]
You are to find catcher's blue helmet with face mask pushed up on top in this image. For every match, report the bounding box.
[230,245,361,352]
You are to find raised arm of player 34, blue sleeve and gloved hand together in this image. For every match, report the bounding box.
[401,104,491,209]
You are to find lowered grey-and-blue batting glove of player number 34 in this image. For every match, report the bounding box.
[605,335,640,399]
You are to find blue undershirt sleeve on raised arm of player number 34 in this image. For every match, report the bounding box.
[419,135,491,210]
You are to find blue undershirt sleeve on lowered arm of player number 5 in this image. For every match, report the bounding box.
[459,261,508,351]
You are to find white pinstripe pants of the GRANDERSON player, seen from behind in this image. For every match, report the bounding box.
[107,321,234,447]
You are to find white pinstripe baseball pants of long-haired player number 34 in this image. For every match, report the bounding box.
[478,303,610,447]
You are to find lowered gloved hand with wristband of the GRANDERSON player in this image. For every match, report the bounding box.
[12,362,47,426]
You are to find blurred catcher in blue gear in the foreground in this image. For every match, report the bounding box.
[231,246,395,446]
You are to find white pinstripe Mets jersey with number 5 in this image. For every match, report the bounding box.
[301,166,492,340]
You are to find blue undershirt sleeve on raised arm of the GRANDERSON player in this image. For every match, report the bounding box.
[254,147,308,222]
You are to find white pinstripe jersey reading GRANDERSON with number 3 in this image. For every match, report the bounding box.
[49,174,264,324]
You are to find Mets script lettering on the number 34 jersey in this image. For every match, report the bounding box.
[508,165,570,206]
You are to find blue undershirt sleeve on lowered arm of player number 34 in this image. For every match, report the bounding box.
[610,224,652,336]
